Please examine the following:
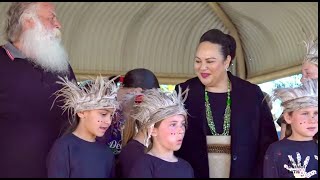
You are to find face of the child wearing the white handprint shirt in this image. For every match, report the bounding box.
[284,107,318,141]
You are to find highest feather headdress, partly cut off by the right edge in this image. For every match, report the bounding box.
[303,39,318,66]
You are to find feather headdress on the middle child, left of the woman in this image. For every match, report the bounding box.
[130,87,189,147]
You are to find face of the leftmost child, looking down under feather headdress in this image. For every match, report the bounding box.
[79,109,114,137]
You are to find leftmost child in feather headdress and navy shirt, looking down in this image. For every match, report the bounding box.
[48,76,118,178]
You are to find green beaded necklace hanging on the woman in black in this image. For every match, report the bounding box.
[204,80,231,136]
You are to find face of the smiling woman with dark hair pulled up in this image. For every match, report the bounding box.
[194,42,231,87]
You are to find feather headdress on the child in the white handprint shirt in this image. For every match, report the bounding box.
[272,79,318,112]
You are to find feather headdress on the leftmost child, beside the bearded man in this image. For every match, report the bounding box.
[55,76,118,117]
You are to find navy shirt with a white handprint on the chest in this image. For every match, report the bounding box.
[263,138,318,178]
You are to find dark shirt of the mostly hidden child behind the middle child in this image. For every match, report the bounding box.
[117,139,145,178]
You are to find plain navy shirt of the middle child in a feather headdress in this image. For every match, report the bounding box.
[129,154,194,178]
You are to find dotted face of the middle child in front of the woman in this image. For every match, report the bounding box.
[151,115,186,151]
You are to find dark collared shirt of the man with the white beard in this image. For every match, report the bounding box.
[0,44,75,178]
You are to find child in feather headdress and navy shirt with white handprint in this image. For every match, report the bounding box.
[264,79,318,178]
